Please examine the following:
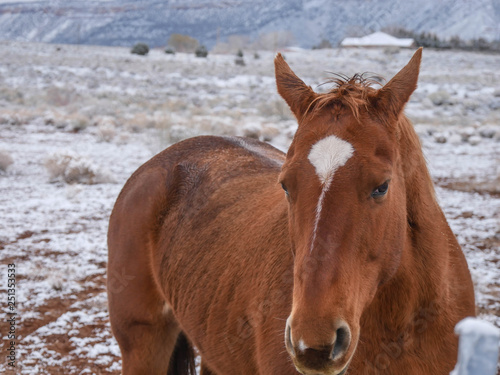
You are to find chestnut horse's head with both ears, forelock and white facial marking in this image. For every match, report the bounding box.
[275,50,422,375]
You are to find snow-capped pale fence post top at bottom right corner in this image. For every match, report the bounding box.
[450,318,500,375]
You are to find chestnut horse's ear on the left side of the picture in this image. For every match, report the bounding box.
[274,53,316,121]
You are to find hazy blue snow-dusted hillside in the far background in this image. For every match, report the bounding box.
[0,0,500,47]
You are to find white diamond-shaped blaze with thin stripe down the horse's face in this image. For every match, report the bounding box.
[308,135,354,252]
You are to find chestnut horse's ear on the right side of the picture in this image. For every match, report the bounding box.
[374,47,422,125]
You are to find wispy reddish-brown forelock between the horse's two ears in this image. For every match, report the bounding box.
[304,73,383,121]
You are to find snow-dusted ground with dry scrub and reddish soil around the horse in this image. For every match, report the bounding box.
[0,42,500,374]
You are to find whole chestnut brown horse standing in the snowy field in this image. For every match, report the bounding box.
[108,50,475,375]
